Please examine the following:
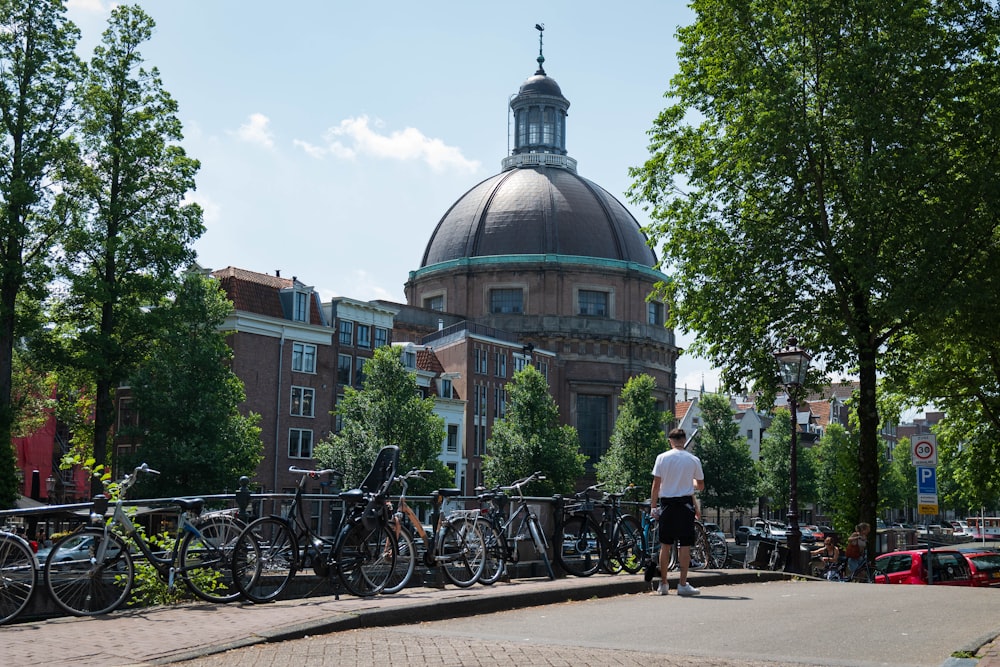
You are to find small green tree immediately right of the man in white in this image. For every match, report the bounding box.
[692,394,757,518]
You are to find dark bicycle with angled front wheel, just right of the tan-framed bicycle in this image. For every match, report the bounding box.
[477,472,556,586]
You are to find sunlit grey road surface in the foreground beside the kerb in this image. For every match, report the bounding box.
[181,581,1000,667]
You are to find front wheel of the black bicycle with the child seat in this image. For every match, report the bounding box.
[232,516,299,603]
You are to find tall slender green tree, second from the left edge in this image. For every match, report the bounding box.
[56,6,204,494]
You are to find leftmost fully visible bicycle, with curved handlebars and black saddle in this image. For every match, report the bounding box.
[44,463,243,616]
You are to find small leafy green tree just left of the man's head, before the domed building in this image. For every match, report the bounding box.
[597,374,668,498]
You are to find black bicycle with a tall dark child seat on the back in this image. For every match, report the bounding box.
[233,446,399,603]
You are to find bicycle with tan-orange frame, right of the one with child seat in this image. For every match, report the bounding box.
[382,469,486,593]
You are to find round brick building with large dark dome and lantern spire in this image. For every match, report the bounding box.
[405,41,678,480]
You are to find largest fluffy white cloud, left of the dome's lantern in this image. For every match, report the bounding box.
[304,116,479,173]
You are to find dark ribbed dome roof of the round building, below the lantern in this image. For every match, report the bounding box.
[420,166,656,267]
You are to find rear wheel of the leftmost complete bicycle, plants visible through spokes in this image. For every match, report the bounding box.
[178,516,244,602]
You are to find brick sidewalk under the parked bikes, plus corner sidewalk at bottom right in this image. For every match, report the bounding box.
[7,569,1000,667]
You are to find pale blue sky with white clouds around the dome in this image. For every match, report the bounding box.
[67,0,717,391]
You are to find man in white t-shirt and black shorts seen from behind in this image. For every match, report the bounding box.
[649,428,705,596]
